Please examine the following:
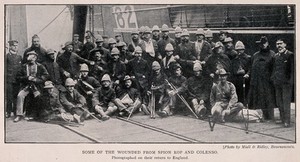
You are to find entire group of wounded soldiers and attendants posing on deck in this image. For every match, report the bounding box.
[6,24,295,127]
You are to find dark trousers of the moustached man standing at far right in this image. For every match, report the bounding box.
[275,84,292,124]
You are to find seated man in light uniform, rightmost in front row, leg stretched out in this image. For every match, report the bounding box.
[210,69,262,122]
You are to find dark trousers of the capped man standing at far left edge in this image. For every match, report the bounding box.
[5,83,19,115]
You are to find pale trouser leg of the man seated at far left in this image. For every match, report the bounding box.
[16,87,40,116]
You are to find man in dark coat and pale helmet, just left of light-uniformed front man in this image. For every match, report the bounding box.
[184,62,212,118]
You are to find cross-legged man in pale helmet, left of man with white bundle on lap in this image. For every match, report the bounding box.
[92,74,126,120]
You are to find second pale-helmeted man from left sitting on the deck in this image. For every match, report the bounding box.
[59,78,89,123]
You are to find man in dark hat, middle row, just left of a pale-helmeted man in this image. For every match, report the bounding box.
[90,48,108,81]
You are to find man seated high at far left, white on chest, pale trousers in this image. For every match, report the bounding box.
[14,51,49,122]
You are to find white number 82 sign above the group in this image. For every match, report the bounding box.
[113,5,138,28]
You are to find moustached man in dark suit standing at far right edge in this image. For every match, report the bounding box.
[271,39,295,127]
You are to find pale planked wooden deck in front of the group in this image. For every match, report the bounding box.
[5,104,296,143]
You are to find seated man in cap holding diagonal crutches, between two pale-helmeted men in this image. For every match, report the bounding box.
[157,63,186,117]
